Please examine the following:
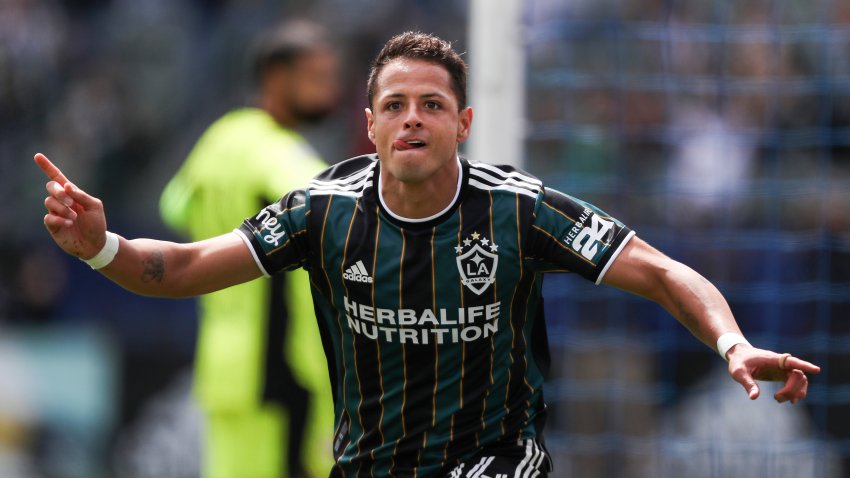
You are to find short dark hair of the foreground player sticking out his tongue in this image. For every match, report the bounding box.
[366,32,467,111]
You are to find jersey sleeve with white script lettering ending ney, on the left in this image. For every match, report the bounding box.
[234,190,309,276]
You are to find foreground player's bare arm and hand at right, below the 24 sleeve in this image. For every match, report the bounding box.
[603,237,820,403]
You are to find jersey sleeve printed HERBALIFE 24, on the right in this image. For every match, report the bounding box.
[525,188,634,284]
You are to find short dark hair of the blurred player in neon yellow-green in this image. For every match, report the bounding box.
[251,20,331,81]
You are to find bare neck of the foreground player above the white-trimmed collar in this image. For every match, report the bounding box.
[380,160,460,219]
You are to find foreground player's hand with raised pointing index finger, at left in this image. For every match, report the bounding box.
[33,153,106,259]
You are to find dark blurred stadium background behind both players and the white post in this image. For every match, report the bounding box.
[0,0,850,477]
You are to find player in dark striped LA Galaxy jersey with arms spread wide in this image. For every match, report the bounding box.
[35,32,819,477]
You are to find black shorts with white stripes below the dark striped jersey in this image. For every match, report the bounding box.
[445,438,552,478]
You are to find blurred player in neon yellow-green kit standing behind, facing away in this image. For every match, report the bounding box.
[160,21,338,478]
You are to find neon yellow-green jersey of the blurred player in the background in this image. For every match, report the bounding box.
[160,108,333,473]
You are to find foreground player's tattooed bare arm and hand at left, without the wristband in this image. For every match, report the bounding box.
[34,153,261,297]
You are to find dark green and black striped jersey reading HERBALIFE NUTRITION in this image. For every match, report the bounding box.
[237,155,633,477]
